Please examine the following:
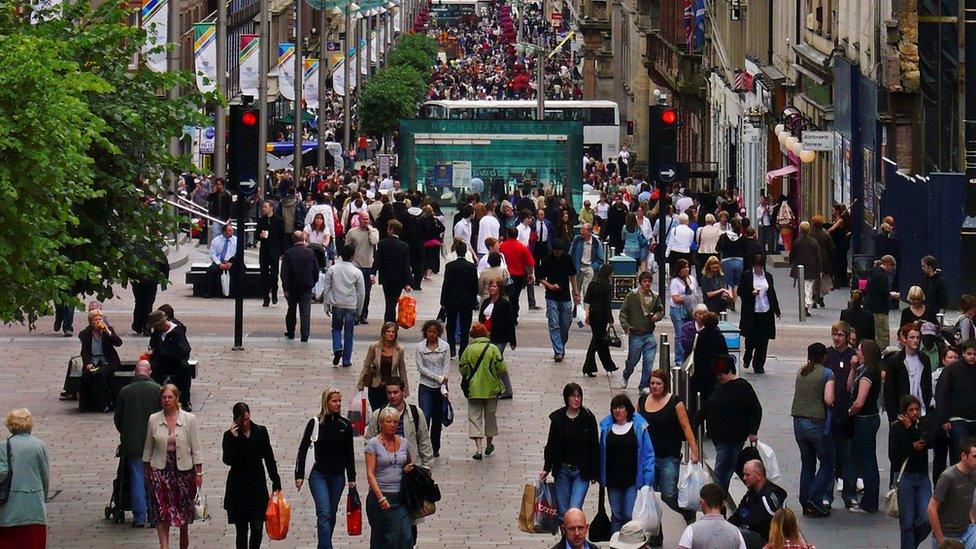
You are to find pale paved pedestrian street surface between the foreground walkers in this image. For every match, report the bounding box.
[0,246,898,548]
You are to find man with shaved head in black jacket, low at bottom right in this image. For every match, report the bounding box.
[729,459,788,547]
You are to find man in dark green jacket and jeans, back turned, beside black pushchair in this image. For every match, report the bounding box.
[115,360,162,528]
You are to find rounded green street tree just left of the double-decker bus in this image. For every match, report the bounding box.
[356,66,427,137]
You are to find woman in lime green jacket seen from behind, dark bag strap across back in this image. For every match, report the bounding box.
[458,322,508,461]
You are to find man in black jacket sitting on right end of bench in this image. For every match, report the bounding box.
[146,309,193,406]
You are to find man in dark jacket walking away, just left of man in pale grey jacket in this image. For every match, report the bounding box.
[281,231,319,343]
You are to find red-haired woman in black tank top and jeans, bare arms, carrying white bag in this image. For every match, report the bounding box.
[638,370,699,541]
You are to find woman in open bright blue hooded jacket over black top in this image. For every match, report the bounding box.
[600,394,654,532]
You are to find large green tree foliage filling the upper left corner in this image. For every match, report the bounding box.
[0,0,216,324]
